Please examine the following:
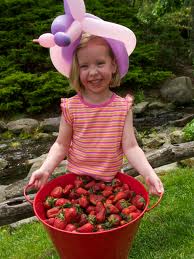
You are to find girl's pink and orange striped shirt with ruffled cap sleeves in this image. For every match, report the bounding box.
[61,94,132,181]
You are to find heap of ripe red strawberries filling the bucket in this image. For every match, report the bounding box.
[44,176,145,233]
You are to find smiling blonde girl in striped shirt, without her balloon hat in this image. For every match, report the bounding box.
[29,34,164,195]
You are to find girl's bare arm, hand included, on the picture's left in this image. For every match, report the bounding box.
[29,115,72,189]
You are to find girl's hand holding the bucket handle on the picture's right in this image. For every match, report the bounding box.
[145,173,164,196]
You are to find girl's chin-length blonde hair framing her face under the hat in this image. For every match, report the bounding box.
[69,33,121,92]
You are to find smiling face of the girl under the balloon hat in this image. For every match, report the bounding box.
[77,38,116,94]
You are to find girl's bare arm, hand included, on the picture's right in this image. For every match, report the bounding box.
[122,110,164,195]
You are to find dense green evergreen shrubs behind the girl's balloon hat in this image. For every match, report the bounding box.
[0,0,191,116]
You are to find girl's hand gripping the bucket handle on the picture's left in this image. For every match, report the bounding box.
[29,169,50,189]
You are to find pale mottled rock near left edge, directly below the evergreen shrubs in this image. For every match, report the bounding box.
[7,118,39,134]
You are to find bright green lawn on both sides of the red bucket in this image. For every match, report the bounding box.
[0,168,194,259]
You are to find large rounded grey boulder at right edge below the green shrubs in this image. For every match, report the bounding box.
[160,76,194,104]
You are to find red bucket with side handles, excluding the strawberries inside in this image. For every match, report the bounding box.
[24,173,162,259]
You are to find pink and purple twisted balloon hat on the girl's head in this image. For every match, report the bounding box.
[34,0,136,78]
